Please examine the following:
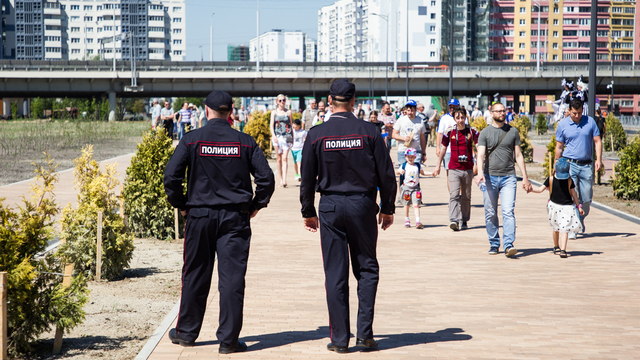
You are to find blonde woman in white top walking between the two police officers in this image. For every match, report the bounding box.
[269,94,293,187]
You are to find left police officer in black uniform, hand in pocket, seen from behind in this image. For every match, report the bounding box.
[164,91,275,354]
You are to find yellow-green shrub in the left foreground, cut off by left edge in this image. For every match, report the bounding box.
[0,154,88,356]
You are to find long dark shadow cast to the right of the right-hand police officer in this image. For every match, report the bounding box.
[368,328,473,351]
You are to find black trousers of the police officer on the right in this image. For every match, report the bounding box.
[318,194,379,346]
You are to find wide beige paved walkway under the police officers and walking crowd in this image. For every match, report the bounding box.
[149,148,640,360]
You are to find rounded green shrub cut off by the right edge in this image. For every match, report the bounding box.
[607,136,640,200]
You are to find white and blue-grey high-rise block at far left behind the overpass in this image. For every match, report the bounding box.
[2,0,186,61]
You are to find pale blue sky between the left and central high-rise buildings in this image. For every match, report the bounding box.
[185,0,336,61]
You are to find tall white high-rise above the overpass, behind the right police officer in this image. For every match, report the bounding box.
[318,0,442,62]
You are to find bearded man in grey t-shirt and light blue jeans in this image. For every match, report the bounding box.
[476,103,531,257]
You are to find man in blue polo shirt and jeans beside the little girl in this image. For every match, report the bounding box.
[555,98,603,239]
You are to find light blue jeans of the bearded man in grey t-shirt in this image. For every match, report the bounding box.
[483,174,518,249]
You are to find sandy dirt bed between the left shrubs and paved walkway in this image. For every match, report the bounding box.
[21,239,182,360]
